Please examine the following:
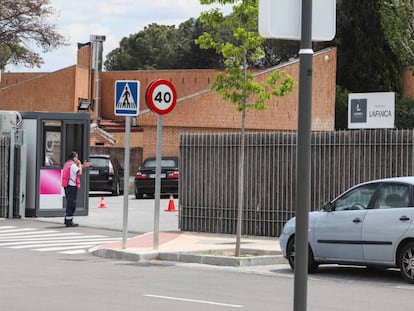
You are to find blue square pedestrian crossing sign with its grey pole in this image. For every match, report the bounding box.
[114,80,140,249]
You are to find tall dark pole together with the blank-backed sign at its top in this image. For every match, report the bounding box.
[259,0,336,311]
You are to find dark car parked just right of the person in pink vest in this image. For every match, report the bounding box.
[89,154,124,195]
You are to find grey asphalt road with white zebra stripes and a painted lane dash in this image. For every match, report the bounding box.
[0,197,414,311]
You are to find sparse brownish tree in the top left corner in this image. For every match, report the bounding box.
[0,0,65,69]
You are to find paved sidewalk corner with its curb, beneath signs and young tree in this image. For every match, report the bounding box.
[89,231,287,266]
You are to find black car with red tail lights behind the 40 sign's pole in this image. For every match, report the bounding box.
[134,157,180,199]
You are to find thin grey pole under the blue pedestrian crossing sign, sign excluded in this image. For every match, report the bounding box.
[122,117,131,249]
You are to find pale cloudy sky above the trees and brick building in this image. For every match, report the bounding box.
[6,0,230,72]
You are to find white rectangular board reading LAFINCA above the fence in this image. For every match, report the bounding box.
[348,92,395,129]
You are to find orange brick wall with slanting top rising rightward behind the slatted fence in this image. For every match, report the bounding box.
[138,49,336,158]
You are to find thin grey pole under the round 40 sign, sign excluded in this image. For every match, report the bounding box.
[153,114,162,250]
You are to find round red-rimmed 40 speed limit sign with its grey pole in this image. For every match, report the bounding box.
[145,80,177,250]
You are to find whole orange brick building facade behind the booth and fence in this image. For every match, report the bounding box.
[0,45,337,158]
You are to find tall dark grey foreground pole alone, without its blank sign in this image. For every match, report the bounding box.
[293,0,313,311]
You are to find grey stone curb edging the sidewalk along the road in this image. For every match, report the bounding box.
[90,249,287,267]
